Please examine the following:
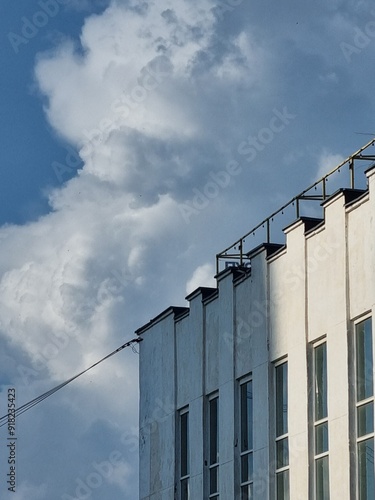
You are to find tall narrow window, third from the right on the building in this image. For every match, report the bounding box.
[275,362,289,500]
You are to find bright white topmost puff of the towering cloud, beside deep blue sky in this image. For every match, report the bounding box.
[36,0,215,145]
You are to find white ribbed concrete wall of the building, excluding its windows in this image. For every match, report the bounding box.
[138,169,375,500]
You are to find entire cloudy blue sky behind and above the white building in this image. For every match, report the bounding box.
[0,0,375,500]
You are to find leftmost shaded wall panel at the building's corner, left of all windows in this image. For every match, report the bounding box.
[139,314,176,500]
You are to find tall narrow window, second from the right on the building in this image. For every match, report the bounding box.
[313,342,329,500]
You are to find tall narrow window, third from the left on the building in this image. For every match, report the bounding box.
[240,380,253,500]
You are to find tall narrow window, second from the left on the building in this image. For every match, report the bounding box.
[208,395,219,500]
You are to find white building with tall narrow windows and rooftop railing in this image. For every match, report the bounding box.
[137,140,375,500]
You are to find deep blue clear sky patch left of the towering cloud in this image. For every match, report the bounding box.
[0,0,107,223]
